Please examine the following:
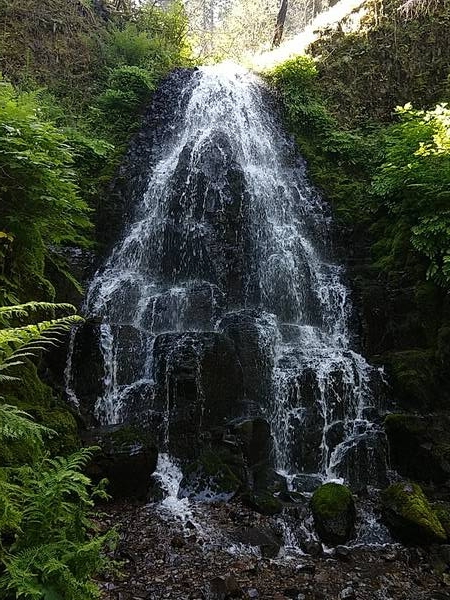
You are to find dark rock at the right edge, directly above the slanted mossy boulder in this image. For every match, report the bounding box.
[385,414,450,484]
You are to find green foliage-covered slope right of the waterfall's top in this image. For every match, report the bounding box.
[267,2,450,289]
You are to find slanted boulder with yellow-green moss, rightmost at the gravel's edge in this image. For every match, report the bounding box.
[381,481,447,545]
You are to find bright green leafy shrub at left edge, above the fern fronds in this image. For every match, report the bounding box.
[0,80,90,304]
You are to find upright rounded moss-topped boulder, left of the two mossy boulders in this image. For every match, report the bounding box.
[311,483,356,546]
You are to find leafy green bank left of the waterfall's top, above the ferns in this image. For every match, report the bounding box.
[0,0,189,305]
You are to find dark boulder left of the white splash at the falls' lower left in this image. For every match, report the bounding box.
[83,426,158,500]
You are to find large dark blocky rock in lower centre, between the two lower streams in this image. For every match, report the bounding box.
[153,332,245,460]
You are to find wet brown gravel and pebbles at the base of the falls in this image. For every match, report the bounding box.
[96,502,450,600]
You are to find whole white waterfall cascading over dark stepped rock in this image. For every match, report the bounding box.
[68,64,385,536]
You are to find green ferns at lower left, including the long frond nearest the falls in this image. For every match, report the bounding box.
[0,302,115,600]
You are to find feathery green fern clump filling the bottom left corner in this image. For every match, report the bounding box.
[0,448,116,600]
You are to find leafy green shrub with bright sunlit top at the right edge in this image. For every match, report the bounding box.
[372,105,450,286]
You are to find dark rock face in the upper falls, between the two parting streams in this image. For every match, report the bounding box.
[160,132,249,302]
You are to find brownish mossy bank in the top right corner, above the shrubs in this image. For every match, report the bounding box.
[310,0,450,126]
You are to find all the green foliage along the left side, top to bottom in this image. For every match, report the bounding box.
[0,0,190,600]
